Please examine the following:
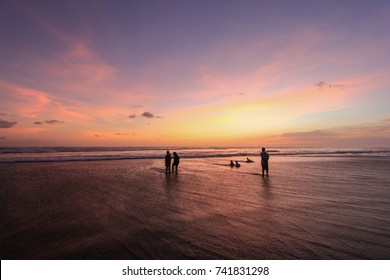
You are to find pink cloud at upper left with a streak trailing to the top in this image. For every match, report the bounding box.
[17,3,117,96]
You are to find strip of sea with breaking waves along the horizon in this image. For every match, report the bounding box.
[0,147,390,163]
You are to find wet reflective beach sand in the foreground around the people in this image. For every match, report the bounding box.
[0,157,390,260]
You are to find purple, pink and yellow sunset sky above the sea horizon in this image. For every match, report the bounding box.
[0,0,390,147]
